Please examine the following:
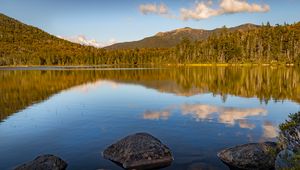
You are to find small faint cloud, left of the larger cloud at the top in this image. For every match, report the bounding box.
[139,4,169,15]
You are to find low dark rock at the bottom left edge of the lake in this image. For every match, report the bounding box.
[15,155,68,170]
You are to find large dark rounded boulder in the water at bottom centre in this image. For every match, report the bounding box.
[103,133,173,169]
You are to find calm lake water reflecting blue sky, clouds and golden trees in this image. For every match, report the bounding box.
[0,67,300,170]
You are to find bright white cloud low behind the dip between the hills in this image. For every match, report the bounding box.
[58,35,118,48]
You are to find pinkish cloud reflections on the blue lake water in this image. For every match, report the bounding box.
[143,104,268,129]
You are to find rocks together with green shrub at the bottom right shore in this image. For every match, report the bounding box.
[218,112,300,170]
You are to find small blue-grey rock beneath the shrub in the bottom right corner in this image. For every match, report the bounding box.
[275,149,295,170]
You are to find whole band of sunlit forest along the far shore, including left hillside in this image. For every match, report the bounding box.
[0,14,300,65]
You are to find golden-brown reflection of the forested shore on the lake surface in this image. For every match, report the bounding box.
[0,67,300,121]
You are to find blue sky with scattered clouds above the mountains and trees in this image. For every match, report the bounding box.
[0,0,300,46]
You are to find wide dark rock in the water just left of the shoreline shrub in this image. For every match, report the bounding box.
[218,142,278,170]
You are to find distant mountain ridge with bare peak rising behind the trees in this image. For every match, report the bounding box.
[105,24,259,49]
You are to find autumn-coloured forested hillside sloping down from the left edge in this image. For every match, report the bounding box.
[0,13,99,66]
